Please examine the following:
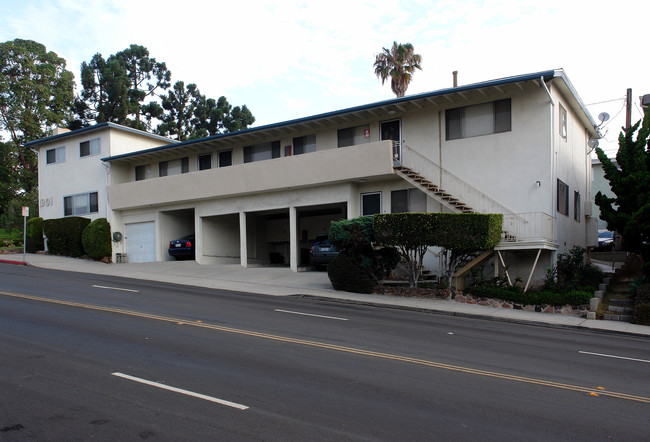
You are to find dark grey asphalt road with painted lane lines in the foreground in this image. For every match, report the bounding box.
[0,265,650,441]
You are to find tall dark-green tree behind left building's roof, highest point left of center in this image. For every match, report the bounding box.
[75,45,171,130]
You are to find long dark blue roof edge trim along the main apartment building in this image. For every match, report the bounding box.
[97,69,596,161]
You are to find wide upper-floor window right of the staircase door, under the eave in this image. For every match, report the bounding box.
[445,98,512,140]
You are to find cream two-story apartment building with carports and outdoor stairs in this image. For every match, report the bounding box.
[30,70,598,288]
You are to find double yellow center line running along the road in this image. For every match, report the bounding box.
[5,291,650,404]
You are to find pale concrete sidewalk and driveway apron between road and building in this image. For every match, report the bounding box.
[0,254,650,336]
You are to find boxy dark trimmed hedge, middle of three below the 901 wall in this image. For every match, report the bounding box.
[43,216,90,258]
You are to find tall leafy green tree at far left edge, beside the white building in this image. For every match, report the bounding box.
[0,39,74,192]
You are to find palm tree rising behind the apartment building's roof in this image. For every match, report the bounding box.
[375,42,422,98]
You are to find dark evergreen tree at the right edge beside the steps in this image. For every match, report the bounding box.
[595,110,650,252]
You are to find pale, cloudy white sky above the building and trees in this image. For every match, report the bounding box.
[0,0,650,156]
